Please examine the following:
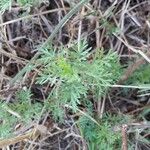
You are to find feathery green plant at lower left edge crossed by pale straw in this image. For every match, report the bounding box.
[0,90,43,139]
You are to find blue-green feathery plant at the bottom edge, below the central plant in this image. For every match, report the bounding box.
[78,116,121,150]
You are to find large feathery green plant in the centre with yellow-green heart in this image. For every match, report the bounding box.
[37,40,120,118]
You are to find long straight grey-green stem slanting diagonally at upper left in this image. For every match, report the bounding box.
[9,0,89,86]
